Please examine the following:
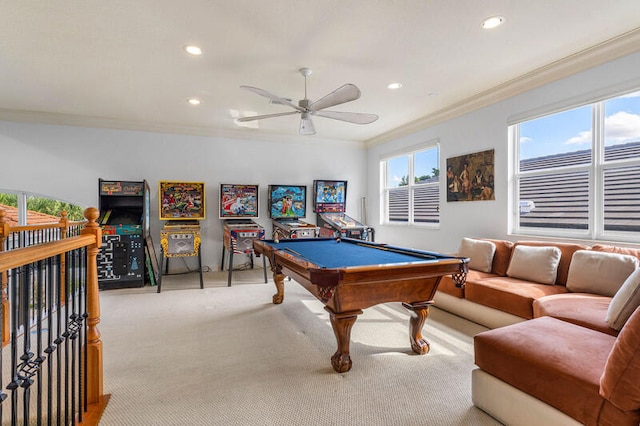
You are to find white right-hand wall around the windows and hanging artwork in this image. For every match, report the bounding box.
[367,53,640,253]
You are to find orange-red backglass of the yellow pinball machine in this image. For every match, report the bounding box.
[158,180,205,220]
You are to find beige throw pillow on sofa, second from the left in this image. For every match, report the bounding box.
[507,245,561,284]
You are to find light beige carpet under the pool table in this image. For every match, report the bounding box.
[99,269,499,426]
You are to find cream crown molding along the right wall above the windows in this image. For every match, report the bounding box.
[365,28,640,148]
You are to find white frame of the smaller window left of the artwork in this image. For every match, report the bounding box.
[379,139,442,229]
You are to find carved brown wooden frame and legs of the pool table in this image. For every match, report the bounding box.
[253,240,469,373]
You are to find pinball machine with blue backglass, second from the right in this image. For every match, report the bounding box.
[269,185,320,241]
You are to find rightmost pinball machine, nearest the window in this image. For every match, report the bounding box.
[313,180,374,241]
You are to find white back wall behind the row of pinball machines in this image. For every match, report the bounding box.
[0,121,366,270]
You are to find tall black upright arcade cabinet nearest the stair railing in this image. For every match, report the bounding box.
[97,179,149,290]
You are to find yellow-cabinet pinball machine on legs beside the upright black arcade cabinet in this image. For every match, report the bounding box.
[157,181,205,293]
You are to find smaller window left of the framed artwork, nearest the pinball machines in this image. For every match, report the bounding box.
[380,143,440,225]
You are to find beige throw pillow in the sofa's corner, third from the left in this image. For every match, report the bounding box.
[567,250,638,297]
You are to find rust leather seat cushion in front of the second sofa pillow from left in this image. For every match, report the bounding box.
[464,276,568,319]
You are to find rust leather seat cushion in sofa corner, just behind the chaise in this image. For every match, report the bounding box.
[533,293,618,336]
